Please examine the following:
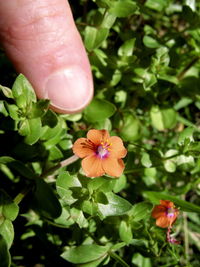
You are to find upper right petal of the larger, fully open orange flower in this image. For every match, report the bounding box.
[108,136,127,159]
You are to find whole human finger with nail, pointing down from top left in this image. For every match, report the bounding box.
[0,0,93,113]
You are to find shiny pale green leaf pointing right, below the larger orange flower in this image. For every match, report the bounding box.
[98,192,132,217]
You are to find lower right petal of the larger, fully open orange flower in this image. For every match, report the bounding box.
[102,157,124,177]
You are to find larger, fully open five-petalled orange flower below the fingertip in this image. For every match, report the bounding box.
[72,129,127,177]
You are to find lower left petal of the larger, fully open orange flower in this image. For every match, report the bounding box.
[81,155,105,177]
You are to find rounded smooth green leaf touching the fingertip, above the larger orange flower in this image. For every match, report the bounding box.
[84,98,116,122]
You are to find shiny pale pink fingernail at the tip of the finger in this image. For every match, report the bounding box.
[45,66,93,113]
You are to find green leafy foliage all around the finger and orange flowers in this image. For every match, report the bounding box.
[0,0,200,267]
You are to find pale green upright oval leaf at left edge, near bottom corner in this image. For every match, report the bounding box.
[0,219,14,248]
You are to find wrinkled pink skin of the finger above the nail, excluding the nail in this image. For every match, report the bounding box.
[0,0,92,109]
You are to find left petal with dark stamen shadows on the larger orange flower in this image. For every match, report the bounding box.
[72,138,95,158]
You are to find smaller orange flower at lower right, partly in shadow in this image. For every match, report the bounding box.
[151,200,179,228]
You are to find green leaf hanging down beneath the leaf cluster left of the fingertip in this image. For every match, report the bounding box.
[25,118,42,145]
